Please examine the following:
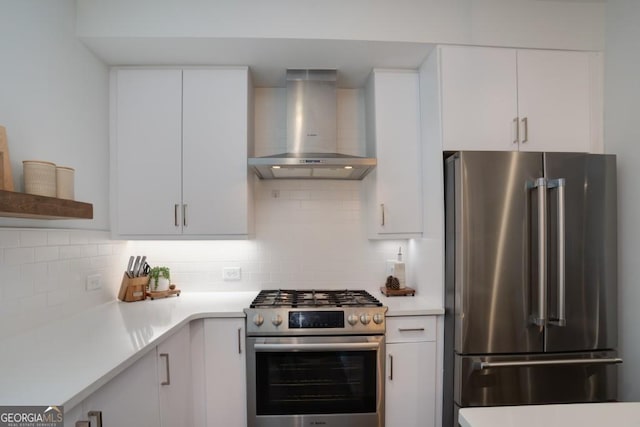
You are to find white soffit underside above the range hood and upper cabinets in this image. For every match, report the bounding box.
[81,37,433,88]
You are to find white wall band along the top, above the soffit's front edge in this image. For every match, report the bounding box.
[78,0,604,50]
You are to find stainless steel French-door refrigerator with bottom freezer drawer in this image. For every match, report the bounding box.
[443,151,621,427]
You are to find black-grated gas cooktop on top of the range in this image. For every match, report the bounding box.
[250,289,382,308]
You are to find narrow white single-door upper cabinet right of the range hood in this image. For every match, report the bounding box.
[363,70,422,239]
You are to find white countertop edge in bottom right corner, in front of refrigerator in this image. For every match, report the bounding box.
[458,402,640,427]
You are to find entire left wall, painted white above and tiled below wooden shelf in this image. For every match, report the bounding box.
[0,0,115,336]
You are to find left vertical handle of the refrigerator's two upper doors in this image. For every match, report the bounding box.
[529,178,547,327]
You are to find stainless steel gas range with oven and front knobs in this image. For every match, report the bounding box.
[244,290,387,427]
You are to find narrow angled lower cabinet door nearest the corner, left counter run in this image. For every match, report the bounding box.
[156,324,193,427]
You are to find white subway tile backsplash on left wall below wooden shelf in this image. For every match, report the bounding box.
[0,229,127,335]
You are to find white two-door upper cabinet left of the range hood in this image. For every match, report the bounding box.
[111,67,252,239]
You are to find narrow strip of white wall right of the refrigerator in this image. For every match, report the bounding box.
[605,0,640,401]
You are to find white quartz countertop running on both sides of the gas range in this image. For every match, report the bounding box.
[0,291,444,409]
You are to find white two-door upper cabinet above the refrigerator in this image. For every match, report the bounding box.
[437,46,602,152]
